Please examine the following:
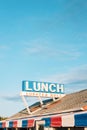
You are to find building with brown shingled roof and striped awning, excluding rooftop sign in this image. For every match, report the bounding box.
[0,89,87,130]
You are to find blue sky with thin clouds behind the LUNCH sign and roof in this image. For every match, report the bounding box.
[0,0,87,116]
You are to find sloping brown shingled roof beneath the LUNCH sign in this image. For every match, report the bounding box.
[8,89,87,119]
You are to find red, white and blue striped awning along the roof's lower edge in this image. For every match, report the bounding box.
[0,111,87,128]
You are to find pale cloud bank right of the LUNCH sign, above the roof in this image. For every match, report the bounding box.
[41,65,87,92]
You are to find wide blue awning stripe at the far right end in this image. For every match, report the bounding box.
[75,113,87,127]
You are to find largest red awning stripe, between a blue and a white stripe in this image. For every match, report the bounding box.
[51,116,62,127]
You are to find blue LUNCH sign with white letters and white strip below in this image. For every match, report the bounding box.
[21,80,64,97]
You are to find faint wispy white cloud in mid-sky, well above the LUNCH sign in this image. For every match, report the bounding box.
[24,40,81,60]
